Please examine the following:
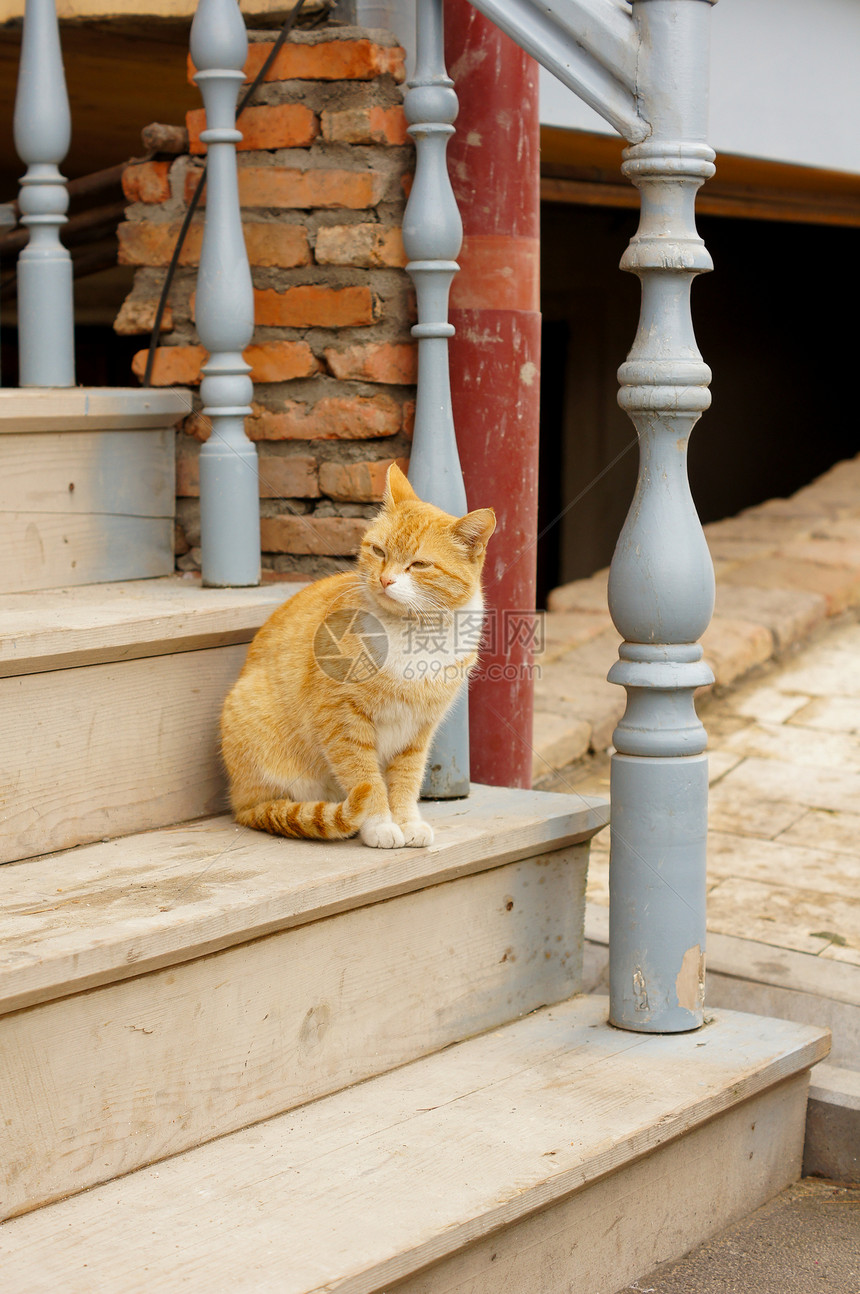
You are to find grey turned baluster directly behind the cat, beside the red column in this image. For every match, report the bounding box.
[403,0,469,800]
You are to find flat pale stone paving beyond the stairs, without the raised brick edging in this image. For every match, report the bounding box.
[556,612,860,983]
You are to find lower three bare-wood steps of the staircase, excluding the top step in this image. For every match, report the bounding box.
[0,392,828,1294]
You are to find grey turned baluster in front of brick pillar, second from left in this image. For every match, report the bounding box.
[191,0,260,586]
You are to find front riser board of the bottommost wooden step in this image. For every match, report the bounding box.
[387,1070,815,1294]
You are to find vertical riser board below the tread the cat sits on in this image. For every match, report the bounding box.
[0,845,587,1216]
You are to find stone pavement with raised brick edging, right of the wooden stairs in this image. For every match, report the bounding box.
[534,458,860,1185]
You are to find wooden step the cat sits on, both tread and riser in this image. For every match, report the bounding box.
[0,787,607,1215]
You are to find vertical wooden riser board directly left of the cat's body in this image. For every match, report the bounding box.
[0,646,246,862]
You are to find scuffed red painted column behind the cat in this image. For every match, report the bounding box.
[445,0,541,787]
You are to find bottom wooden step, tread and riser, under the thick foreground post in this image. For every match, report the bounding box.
[0,996,828,1294]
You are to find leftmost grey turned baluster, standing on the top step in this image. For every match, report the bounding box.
[14,0,75,387]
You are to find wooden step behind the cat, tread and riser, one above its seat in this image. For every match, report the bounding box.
[0,576,299,862]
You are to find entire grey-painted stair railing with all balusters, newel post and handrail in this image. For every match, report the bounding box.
[16,0,714,1031]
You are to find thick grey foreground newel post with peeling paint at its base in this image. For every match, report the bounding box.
[609,0,714,1033]
